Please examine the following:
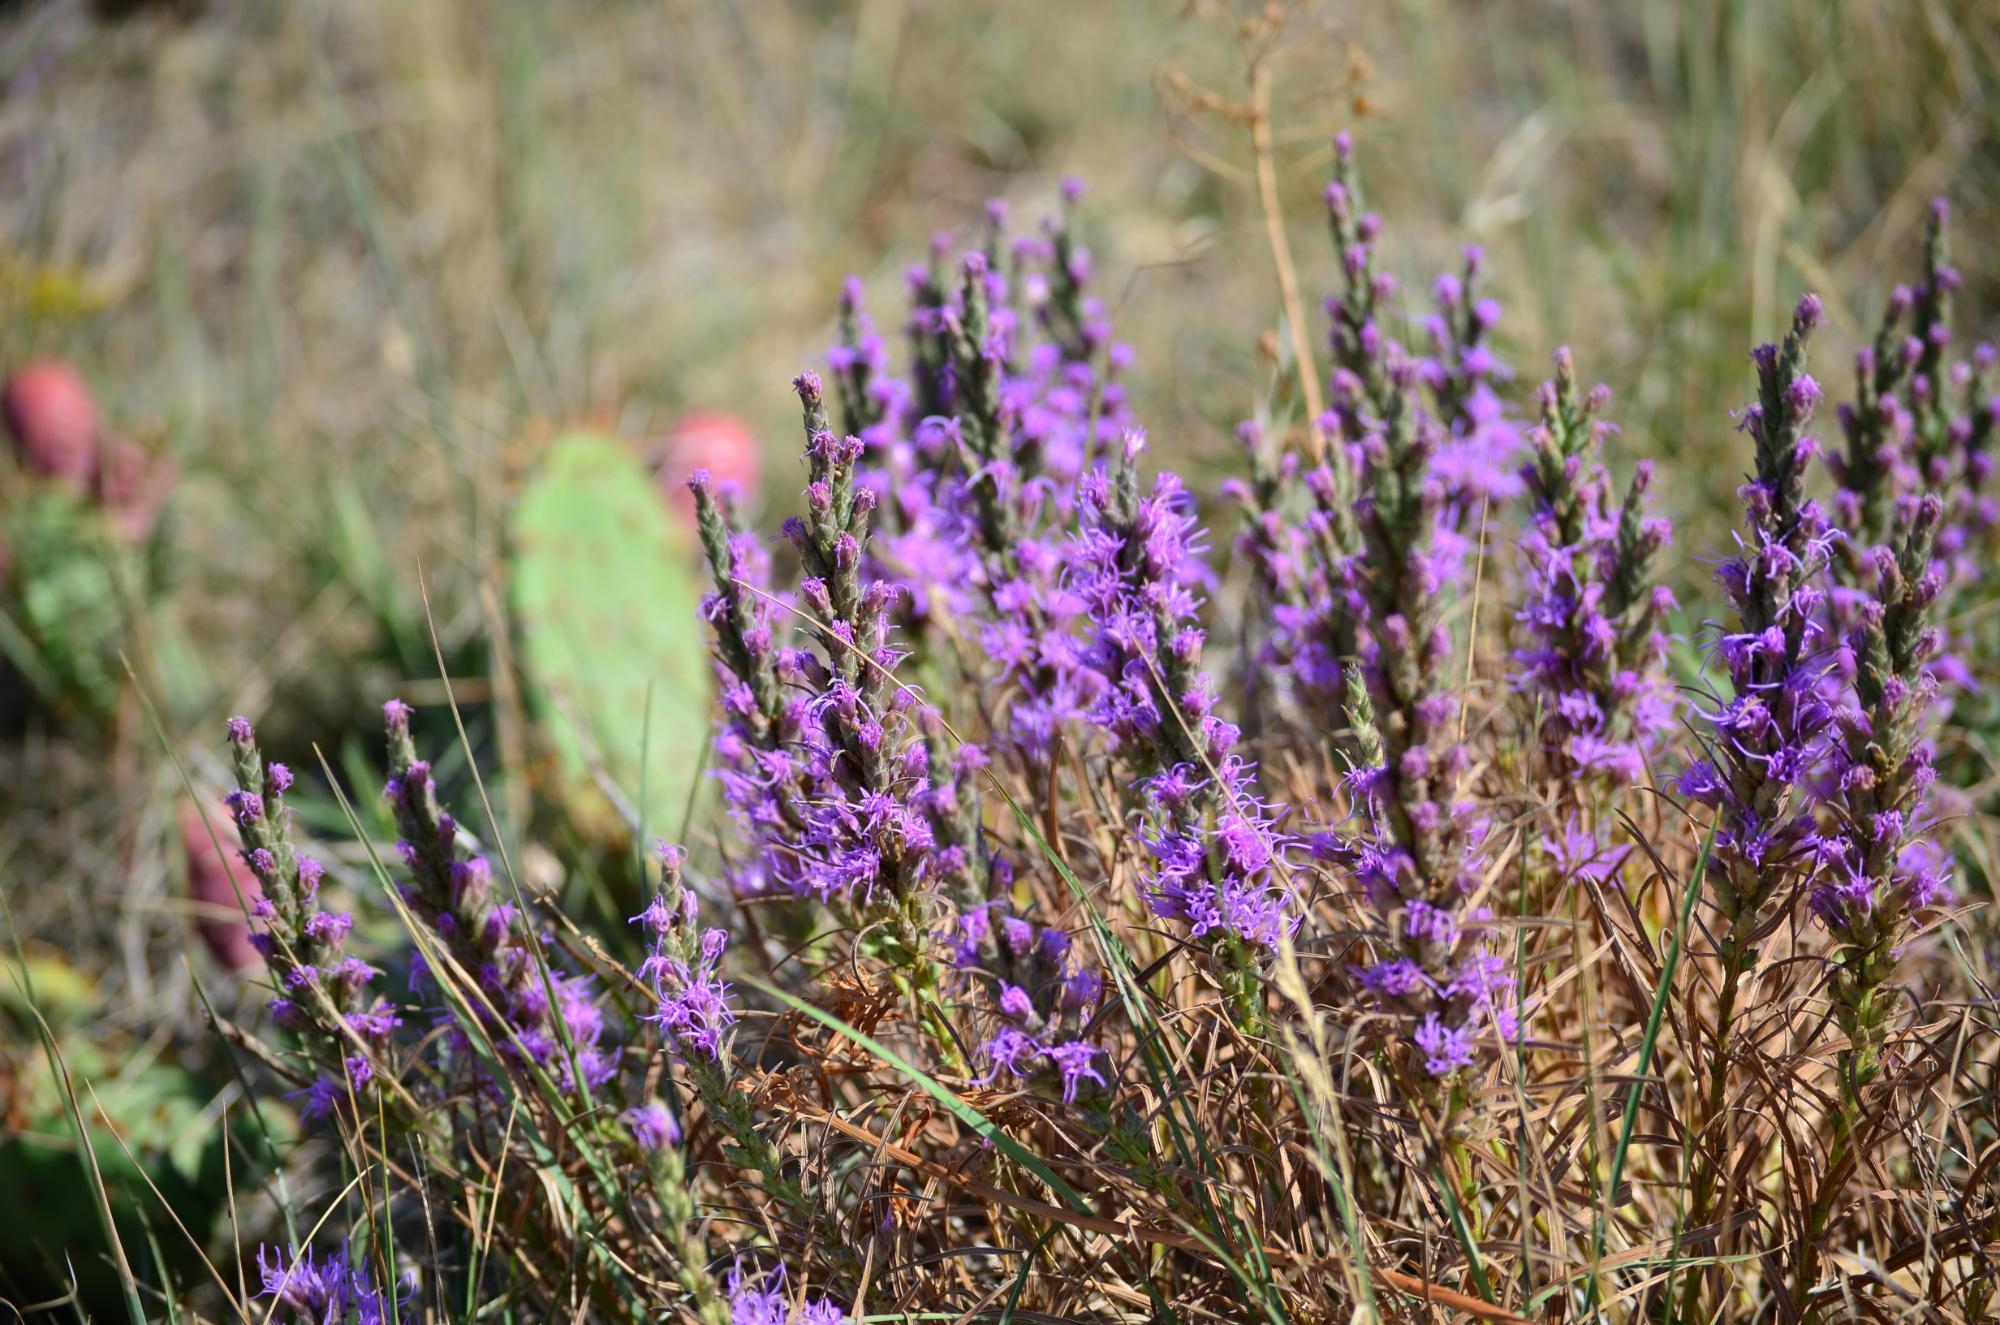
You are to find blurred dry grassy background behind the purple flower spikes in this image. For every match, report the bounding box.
[0,0,2000,1304]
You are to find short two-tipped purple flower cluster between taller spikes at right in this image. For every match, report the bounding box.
[1512,350,1674,785]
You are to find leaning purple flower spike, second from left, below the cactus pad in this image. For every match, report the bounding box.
[382,699,618,1093]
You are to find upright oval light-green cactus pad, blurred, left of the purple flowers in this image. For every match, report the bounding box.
[508,432,708,837]
